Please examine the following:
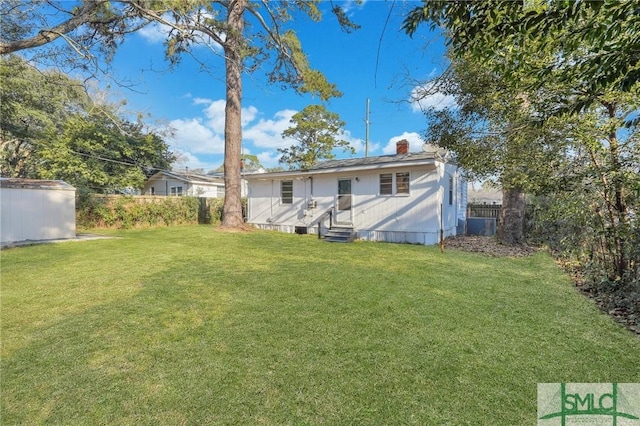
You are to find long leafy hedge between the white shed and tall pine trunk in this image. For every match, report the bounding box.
[76,194,224,229]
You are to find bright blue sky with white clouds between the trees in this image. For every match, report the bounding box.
[107,0,451,171]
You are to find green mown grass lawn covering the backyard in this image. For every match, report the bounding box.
[0,226,640,425]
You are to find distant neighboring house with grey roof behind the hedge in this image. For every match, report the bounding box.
[142,171,230,198]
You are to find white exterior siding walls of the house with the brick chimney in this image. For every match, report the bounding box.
[248,163,466,244]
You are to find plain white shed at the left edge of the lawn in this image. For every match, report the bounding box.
[0,178,76,243]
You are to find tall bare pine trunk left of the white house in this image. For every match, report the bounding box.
[222,0,246,228]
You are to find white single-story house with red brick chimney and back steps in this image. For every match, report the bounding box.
[245,140,467,244]
